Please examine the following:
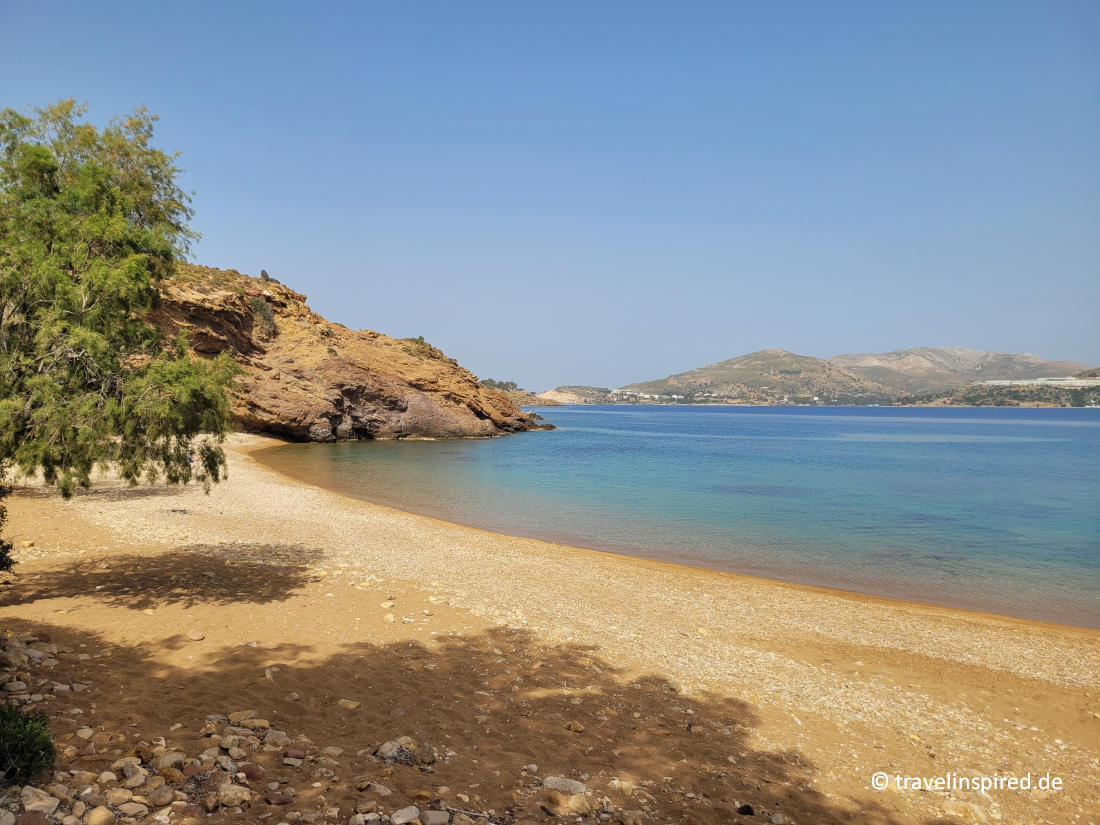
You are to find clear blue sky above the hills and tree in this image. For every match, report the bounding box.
[0,0,1100,391]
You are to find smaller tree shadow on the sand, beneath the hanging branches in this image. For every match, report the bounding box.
[0,543,319,611]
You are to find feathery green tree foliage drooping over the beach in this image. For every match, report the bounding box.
[0,100,237,496]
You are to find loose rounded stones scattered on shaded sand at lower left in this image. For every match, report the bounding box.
[0,633,638,825]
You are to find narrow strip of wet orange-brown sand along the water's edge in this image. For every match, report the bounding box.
[251,440,1100,639]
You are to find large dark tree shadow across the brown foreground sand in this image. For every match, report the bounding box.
[0,616,915,825]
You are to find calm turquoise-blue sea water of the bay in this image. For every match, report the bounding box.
[260,406,1100,627]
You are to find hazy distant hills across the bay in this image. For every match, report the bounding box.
[545,347,1089,404]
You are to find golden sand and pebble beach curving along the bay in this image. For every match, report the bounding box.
[0,435,1100,825]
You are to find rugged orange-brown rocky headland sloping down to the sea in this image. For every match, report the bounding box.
[152,264,541,441]
